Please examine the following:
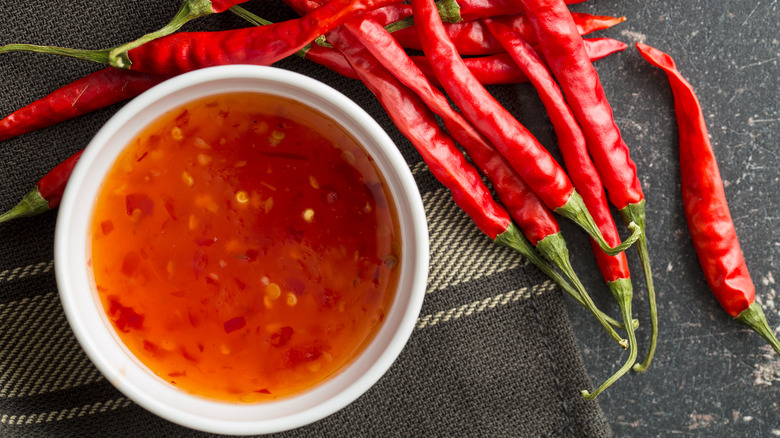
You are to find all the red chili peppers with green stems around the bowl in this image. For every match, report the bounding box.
[0,0,780,398]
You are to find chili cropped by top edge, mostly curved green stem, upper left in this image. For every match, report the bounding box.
[108,0,247,68]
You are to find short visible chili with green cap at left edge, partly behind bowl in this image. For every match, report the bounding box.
[0,150,83,223]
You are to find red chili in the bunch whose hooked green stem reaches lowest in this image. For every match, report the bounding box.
[485,17,637,399]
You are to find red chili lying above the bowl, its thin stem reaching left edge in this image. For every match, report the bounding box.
[0,0,397,75]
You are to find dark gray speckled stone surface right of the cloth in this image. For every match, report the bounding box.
[556,0,780,437]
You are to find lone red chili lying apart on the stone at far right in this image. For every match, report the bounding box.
[636,43,780,354]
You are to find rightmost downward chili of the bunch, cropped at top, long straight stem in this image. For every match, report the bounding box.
[517,0,658,372]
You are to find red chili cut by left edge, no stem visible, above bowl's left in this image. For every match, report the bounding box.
[0,67,167,141]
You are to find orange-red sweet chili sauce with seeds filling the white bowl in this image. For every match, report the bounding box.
[91,93,401,402]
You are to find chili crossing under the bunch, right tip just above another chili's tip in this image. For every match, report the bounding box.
[393,12,625,55]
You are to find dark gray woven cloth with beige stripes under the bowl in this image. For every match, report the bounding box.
[0,0,611,437]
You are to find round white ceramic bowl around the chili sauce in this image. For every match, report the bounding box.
[54,65,428,435]
